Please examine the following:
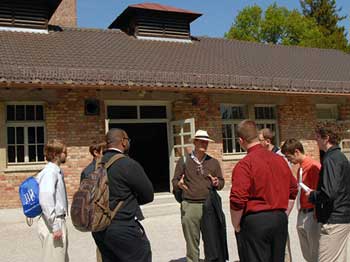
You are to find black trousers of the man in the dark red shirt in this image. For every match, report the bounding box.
[236,211,288,262]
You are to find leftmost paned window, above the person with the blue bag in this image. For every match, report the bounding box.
[6,103,46,165]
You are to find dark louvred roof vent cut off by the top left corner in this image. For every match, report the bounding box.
[0,0,61,30]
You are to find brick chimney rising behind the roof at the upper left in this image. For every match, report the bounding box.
[49,0,77,27]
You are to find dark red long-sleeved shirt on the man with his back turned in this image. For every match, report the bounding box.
[230,144,298,214]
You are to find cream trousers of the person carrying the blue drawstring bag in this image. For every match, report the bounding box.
[38,217,69,262]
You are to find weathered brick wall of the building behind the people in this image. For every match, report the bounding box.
[0,90,350,208]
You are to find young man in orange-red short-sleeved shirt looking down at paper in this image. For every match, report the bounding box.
[282,138,321,262]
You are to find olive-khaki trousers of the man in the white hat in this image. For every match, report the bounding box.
[181,201,203,262]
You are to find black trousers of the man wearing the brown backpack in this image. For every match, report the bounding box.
[92,221,152,262]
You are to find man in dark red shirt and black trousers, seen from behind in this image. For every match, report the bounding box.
[230,120,298,262]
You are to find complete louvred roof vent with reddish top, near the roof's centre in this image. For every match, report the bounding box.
[108,3,202,40]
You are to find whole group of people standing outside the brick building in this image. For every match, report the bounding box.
[33,120,350,262]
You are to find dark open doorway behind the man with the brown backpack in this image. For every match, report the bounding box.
[109,123,170,192]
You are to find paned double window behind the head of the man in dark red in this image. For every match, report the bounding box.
[220,104,278,156]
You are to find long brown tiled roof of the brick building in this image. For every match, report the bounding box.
[0,26,350,94]
